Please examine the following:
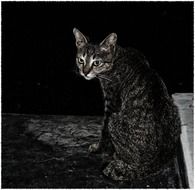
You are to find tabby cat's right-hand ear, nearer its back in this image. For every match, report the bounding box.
[100,33,117,51]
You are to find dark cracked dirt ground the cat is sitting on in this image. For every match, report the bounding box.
[2,114,182,188]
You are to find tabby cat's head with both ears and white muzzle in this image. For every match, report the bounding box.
[73,28,117,80]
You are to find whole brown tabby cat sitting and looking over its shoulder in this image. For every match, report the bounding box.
[73,28,181,180]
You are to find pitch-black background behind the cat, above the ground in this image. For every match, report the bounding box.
[2,2,193,115]
